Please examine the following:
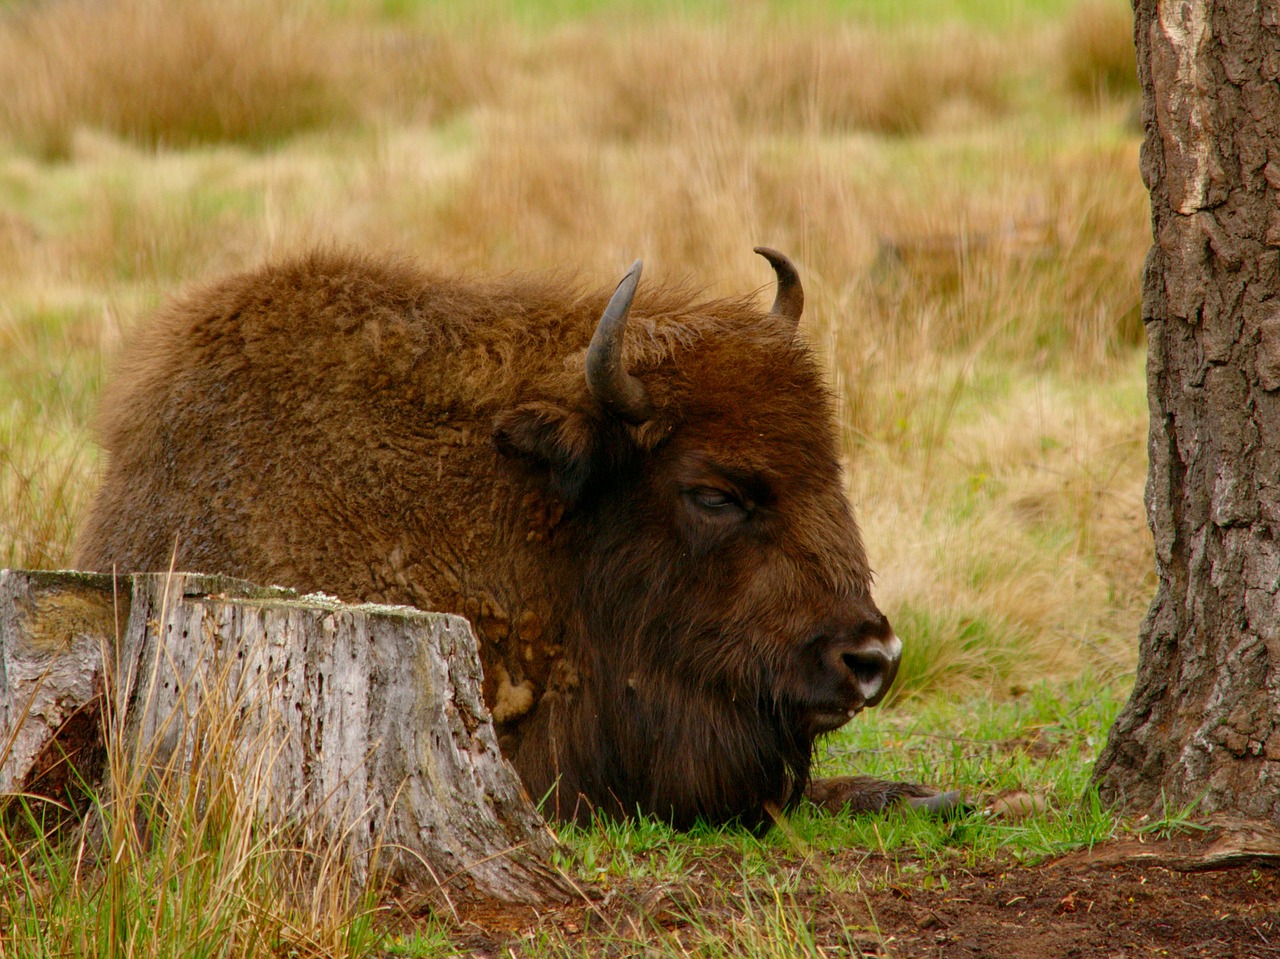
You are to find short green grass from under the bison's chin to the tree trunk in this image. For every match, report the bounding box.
[559,677,1126,883]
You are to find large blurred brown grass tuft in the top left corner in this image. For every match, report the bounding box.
[0,0,351,157]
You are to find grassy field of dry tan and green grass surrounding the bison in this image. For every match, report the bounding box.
[0,0,1153,955]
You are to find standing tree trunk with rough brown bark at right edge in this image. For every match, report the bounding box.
[1096,0,1280,822]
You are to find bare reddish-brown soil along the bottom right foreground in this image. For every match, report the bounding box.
[412,840,1280,959]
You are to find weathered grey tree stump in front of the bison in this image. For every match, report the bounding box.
[0,571,570,903]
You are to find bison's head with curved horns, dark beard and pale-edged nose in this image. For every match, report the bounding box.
[494,247,901,826]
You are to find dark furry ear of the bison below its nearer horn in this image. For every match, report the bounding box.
[493,402,594,506]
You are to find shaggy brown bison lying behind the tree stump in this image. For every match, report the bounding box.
[77,247,901,827]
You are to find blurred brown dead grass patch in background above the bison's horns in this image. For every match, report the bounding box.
[545,17,1011,141]
